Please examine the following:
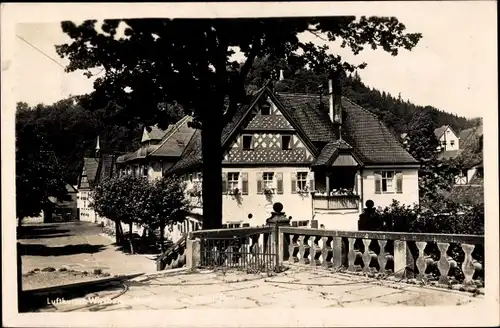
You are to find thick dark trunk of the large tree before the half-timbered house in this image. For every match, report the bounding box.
[201,105,222,229]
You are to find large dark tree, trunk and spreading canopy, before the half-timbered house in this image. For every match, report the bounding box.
[57,16,421,228]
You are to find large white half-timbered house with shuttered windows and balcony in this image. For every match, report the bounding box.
[166,81,420,230]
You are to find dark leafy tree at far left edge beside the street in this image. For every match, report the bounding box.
[16,103,69,224]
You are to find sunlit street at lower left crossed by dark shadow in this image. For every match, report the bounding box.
[18,222,156,274]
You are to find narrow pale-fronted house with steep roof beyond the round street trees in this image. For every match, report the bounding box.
[77,154,116,224]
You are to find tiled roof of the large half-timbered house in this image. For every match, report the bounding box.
[170,86,419,172]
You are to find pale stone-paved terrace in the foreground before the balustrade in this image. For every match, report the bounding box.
[42,267,484,312]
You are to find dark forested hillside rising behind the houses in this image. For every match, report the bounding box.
[16,60,474,184]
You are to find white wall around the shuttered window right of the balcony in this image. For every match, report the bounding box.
[362,168,418,207]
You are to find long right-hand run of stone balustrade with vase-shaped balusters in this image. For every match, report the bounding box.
[279,227,484,285]
